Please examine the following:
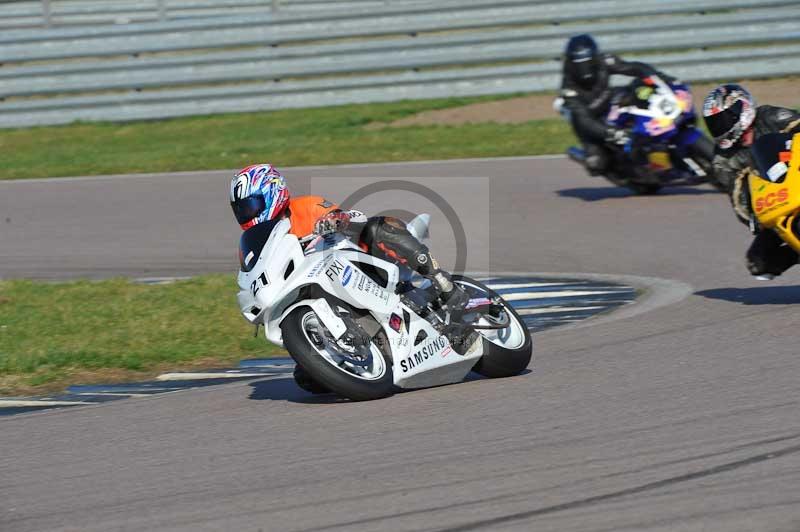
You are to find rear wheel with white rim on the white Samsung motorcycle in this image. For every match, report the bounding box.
[453,275,533,379]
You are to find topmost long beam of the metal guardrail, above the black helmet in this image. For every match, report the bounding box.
[0,0,797,46]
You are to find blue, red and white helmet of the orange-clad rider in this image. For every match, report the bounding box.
[231,163,289,229]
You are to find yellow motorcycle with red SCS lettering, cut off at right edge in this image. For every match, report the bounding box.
[748,133,800,253]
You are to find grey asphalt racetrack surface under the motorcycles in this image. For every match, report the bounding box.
[0,158,800,532]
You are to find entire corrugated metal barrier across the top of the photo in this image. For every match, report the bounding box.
[0,0,800,127]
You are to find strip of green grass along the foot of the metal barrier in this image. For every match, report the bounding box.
[0,96,572,179]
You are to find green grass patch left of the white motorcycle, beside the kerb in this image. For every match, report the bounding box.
[0,275,283,395]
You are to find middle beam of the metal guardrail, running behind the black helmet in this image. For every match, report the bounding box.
[0,18,800,98]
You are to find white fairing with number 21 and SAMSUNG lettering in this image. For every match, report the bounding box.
[237,214,483,388]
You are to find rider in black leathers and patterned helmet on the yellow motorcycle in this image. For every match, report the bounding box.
[703,83,800,279]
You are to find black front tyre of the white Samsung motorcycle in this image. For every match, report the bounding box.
[281,306,395,401]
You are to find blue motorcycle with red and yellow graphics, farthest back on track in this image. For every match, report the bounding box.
[567,75,724,194]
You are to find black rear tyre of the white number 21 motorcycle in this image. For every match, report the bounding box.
[453,275,533,379]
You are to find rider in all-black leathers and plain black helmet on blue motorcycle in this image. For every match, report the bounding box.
[560,34,672,175]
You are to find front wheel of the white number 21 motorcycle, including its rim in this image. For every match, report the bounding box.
[281,306,394,401]
